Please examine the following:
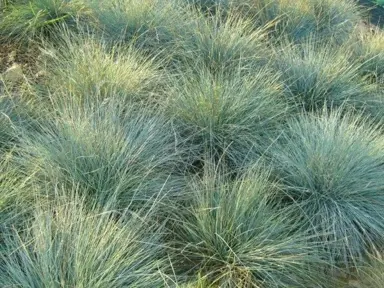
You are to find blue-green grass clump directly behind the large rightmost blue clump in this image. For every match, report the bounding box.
[273,41,375,111]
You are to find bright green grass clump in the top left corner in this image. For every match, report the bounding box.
[0,0,86,44]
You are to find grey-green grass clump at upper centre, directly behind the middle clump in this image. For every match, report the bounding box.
[177,13,269,73]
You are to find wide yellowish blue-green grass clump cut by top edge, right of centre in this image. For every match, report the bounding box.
[232,0,361,43]
